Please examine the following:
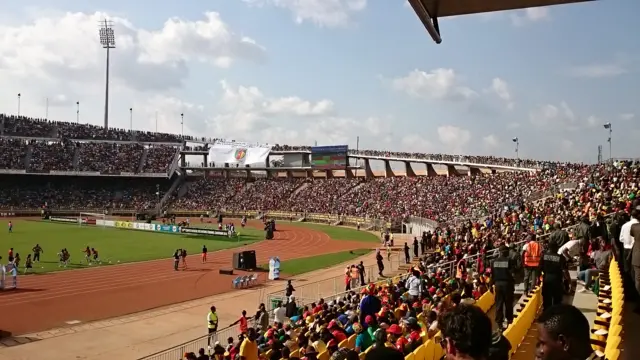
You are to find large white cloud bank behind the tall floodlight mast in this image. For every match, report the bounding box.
[0,12,265,93]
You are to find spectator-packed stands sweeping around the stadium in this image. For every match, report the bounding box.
[0,115,640,360]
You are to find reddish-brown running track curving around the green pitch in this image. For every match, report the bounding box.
[0,224,363,336]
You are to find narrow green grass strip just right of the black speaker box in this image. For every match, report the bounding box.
[260,249,373,275]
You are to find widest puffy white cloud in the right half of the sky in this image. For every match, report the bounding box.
[391,68,478,101]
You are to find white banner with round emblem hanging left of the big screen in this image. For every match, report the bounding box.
[208,143,271,167]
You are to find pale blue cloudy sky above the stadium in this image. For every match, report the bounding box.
[0,0,640,162]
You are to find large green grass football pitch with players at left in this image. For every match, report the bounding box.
[0,220,264,273]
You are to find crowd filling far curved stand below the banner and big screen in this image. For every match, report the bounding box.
[171,165,596,223]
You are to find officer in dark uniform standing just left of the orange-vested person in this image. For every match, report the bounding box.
[491,245,515,328]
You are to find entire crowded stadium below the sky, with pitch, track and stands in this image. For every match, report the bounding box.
[0,0,640,360]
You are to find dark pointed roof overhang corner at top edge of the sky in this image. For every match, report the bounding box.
[408,0,595,44]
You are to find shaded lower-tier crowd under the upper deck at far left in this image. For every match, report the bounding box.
[0,175,170,212]
